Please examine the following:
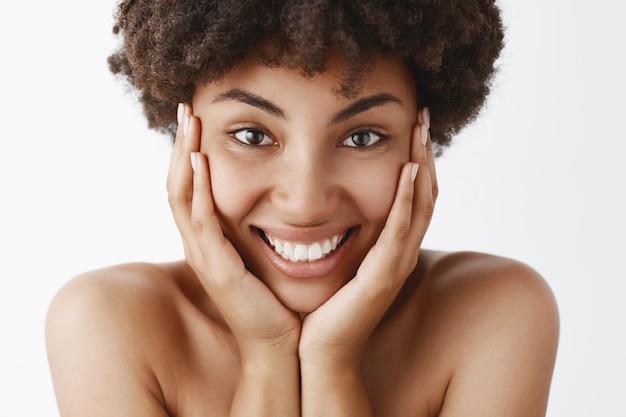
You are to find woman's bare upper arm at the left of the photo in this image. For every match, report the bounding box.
[46,266,172,417]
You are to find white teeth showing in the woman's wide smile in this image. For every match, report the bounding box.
[258,228,353,262]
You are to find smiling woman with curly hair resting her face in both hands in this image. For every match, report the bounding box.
[47,0,558,416]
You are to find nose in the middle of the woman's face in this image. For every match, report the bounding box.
[272,149,340,226]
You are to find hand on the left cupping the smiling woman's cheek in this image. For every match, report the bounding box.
[167,104,301,360]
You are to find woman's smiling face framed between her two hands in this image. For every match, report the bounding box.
[193,56,417,312]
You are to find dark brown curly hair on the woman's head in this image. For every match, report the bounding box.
[108,0,504,150]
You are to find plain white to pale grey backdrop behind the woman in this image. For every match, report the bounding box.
[0,0,626,417]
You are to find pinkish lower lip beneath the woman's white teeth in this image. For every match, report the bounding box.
[258,230,357,279]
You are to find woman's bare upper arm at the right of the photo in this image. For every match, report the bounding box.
[432,255,559,417]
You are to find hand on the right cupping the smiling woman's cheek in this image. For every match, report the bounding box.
[299,109,437,368]
